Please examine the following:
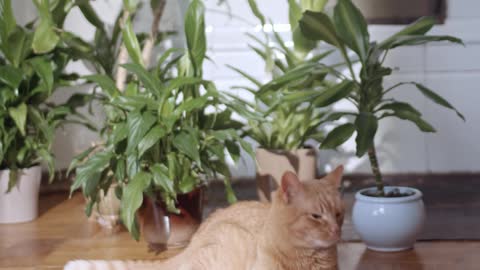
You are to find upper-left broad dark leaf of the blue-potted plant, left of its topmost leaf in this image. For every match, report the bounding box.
[299,10,343,48]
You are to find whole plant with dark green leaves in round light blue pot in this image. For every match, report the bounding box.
[300,0,464,251]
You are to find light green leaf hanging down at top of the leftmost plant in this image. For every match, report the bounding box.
[32,0,60,54]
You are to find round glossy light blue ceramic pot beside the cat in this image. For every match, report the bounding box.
[352,186,425,252]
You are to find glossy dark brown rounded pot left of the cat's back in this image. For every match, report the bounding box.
[139,188,205,252]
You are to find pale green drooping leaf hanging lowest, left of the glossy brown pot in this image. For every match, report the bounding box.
[120,171,152,241]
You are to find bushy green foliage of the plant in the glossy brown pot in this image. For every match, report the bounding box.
[71,0,251,239]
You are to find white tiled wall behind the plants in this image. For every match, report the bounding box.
[205,0,480,176]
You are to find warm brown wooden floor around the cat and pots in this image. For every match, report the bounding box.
[0,195,480,270]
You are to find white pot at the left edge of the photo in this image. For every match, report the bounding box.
[0,166,42,224]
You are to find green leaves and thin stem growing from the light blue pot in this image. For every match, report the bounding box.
[300,0,464,196]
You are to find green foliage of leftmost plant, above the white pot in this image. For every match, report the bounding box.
[0,0,94,190]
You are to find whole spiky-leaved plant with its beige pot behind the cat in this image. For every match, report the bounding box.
[231,1,331,201]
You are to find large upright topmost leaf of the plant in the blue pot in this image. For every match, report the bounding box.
[333,0,370,61]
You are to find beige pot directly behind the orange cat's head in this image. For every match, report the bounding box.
[256,148,316,201]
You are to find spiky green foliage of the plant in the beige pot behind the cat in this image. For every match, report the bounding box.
[230,0,330,150]
